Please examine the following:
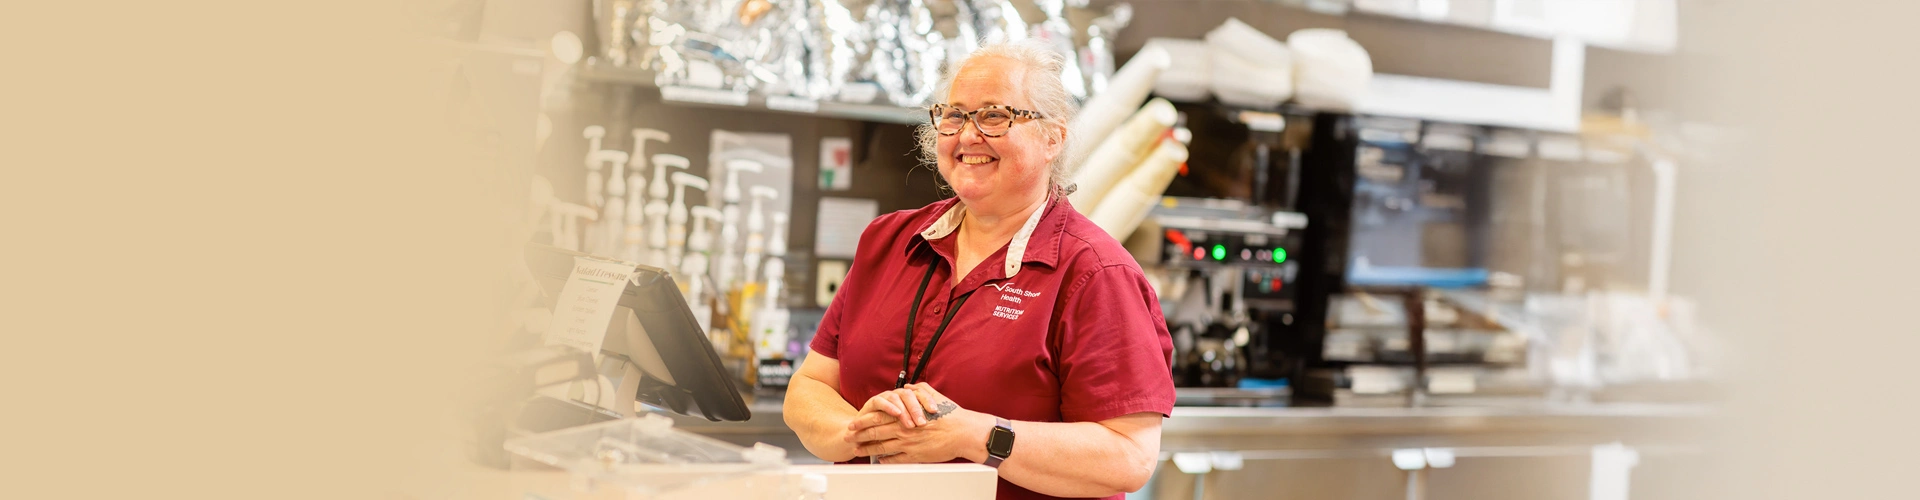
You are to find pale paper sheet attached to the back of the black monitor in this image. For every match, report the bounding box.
[547,258,634,356]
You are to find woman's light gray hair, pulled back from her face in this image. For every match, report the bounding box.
[916,38,1079,192]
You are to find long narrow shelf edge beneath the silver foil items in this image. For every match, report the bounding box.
[578,62,927,125]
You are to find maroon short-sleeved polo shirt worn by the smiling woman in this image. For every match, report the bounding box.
[812,196,1173,500]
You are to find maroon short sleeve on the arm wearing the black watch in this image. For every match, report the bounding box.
[1058,265,1173,421]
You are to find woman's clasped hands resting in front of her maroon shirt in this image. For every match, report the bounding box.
[843,383,995,463]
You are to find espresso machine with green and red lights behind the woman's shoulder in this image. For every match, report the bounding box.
[1125,104,1309,406]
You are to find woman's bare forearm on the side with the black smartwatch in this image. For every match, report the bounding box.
[966,413,1160,496]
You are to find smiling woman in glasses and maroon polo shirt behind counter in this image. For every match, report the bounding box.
[783,44,1173,498]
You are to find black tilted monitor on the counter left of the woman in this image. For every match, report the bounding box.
[526,244,751,421]
